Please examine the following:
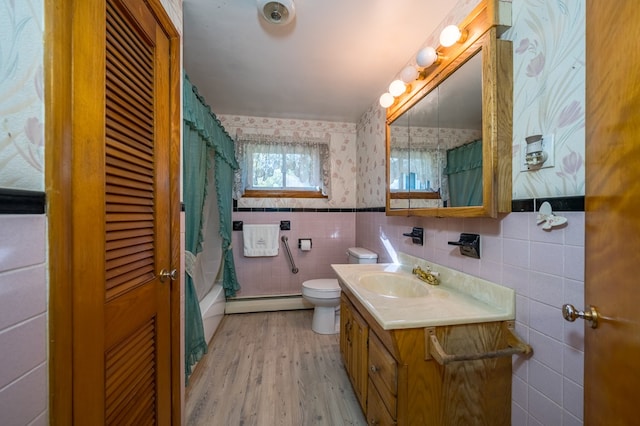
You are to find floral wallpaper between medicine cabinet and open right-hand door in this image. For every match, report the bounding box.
[503,0,585,199]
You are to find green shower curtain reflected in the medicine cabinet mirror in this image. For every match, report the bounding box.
[445,140,482,207]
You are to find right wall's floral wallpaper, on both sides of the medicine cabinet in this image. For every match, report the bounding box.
[356,0,585,208]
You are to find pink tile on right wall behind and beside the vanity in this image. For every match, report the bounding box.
[356,212,585,425]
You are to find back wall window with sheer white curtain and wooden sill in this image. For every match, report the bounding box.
[236,136,330,198]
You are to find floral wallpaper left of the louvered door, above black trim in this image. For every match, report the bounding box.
[0,0,44,191]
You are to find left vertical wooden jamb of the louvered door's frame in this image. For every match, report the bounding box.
[44,0,73,426]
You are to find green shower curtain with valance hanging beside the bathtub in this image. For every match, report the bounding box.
[183,75,240,379]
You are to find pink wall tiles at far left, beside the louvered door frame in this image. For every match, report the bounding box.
[0,215,48,425]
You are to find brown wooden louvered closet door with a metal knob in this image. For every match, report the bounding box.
[74,0,176,425]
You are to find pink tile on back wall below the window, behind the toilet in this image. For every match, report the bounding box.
[232,212,356,297]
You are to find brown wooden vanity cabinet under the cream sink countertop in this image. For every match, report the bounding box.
[340,287,511,426]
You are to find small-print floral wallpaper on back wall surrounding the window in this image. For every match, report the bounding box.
[218,115,356,208]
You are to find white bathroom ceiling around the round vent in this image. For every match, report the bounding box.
[183,0,456,122]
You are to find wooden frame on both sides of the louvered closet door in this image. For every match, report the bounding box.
[43,0,183,425]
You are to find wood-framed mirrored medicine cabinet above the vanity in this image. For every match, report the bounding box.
[386,0,513,217]
